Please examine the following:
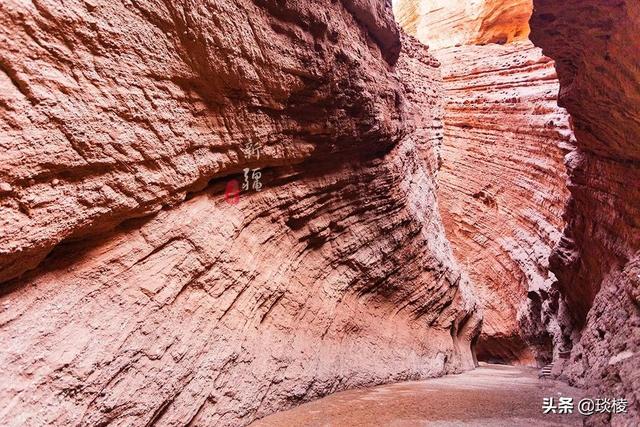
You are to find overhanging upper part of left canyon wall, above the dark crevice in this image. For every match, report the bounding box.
[0,0,402,281]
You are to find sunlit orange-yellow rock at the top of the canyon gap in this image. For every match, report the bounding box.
[394,0,531,49]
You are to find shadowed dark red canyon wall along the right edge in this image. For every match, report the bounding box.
[531,0,640,425]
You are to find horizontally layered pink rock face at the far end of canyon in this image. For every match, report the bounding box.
[434,42,573,366]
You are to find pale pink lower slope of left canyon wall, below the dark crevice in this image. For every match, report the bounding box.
[0,146,478,426]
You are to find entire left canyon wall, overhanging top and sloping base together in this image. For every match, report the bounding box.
[0,0,481,426]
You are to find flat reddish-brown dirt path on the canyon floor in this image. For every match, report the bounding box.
[252,365,582,427]
